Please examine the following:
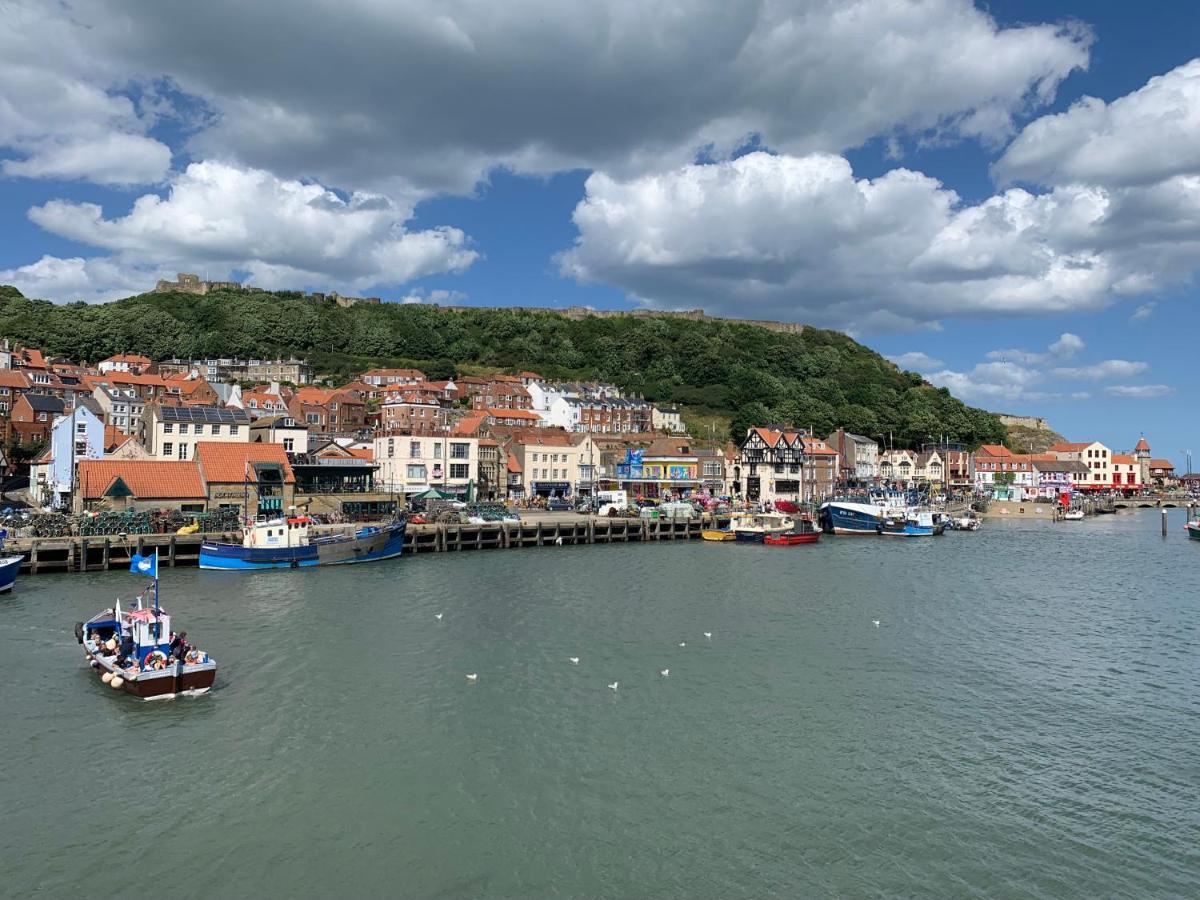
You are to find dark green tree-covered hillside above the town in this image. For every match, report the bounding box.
[0,288,1004,444]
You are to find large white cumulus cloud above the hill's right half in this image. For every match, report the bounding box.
[559,152,1200,333]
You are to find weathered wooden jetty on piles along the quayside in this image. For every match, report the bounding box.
[6,516,728,575]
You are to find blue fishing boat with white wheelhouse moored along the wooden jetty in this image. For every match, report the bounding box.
[200,516,408,570]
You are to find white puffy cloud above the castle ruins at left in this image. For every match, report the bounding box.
[19,162,479,299]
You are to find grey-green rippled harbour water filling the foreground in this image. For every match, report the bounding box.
[0,510,1200,898]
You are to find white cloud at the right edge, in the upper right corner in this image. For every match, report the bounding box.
[995,59,1200,187]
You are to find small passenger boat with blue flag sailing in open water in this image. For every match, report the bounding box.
[74,553,217,700]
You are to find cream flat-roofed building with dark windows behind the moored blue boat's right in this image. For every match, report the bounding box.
[374,434,479,494]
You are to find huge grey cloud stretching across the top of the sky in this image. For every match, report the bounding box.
[0,0,1091,197]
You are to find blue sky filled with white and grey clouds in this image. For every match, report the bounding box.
[0,0,1200,467]
